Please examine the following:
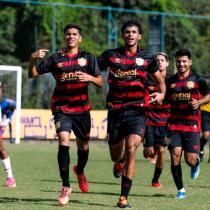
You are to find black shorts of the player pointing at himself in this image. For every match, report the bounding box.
[54,112,91,141]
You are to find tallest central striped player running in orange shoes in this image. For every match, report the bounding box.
[98,21,165,208]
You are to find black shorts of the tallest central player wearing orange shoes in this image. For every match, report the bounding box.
[107,110,146,145]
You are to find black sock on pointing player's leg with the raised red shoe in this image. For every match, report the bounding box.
[77,149,89,174]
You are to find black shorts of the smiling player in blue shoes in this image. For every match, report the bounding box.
[167,131,200,154]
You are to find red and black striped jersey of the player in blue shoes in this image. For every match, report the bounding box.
[166,71,209,132]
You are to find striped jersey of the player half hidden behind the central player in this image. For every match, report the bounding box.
[146,75,170,126]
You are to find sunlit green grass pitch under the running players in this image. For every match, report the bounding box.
[0,142,210,210]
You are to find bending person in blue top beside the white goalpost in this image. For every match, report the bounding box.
[0,99,16,143]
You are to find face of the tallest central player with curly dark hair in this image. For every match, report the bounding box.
[122,26,142,47]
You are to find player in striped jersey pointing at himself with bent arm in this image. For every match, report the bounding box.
[28,24,103,205]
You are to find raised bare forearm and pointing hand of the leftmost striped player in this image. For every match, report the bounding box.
[28,49,49,78]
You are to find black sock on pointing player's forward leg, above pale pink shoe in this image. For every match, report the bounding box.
[58,145,70,187]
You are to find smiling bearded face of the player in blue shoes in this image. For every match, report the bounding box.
[175,56,192,74]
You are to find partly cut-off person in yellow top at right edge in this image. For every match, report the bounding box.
[199,102,210,163]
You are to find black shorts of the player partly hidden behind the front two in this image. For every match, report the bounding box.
[144,125,167,148]
